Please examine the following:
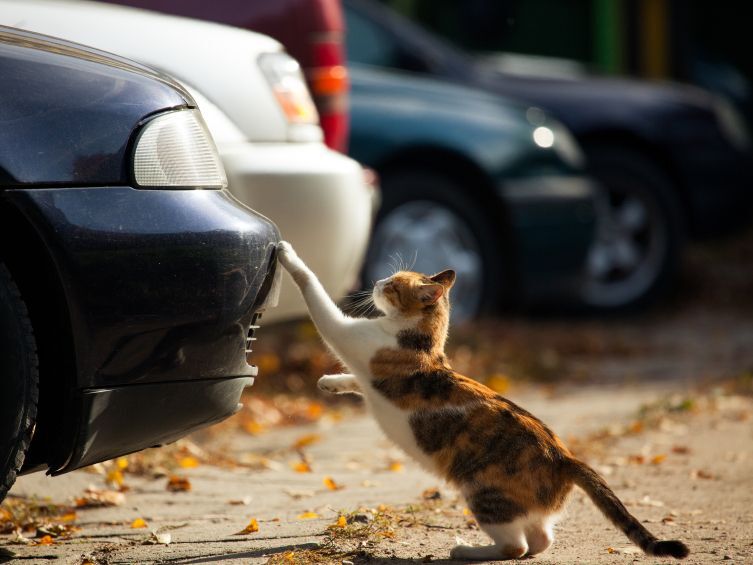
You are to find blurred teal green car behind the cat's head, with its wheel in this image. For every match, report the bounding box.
[349,65,594,320]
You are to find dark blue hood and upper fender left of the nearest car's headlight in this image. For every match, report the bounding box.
[0,28,188,187]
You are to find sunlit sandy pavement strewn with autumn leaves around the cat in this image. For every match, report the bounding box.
[0,376,753,563]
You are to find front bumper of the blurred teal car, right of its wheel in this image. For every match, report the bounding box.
[499,175,596,305]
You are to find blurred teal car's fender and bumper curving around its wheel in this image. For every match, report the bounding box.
[350,65,595,304]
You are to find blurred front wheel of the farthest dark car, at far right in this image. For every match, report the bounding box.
[582,148,683,312]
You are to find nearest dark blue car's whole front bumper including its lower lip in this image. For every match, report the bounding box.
[4,186,280,474]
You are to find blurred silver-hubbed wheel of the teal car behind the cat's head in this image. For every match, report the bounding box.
[363,171,504,322]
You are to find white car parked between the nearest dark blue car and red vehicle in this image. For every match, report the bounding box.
[0,0,375,322]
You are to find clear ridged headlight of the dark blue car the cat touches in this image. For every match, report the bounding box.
[133,109,227,189]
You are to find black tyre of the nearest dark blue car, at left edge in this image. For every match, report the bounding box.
[0,262,39,500]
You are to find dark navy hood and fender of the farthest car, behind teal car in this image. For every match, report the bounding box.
[343,0,753,237]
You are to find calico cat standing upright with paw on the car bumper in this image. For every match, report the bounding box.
[278,242,689,559]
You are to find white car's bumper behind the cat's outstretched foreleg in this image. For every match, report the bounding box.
[218,142,376,322]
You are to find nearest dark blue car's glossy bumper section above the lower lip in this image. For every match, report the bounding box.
[6,187,279,388]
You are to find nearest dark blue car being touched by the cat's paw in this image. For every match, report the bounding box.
[0,28,279,499]
